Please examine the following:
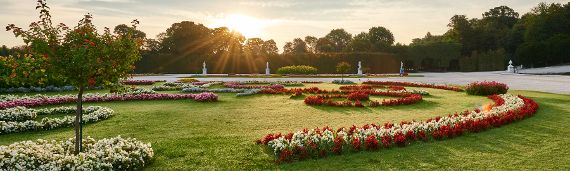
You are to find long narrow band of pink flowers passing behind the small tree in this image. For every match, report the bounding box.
[0,94,217,109]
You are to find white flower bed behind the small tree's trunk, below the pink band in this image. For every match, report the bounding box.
[0,106,113,134]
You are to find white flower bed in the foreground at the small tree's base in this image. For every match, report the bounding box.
[0,136,154,170]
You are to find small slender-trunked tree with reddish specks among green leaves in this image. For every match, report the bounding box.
[6,0,143,154]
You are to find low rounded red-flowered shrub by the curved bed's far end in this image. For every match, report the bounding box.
[465,81,509,96]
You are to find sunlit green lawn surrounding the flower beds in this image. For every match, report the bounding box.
[0,84,570,170]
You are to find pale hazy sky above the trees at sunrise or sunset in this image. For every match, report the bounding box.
[0,0,567,50]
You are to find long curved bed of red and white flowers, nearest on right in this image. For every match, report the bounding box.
[257,94,538,162]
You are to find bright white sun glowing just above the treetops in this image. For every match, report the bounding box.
[214,14,267,38]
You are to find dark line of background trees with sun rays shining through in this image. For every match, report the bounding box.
[0,3,570,73]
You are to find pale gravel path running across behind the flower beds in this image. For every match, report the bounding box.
[133,71,570,94]
